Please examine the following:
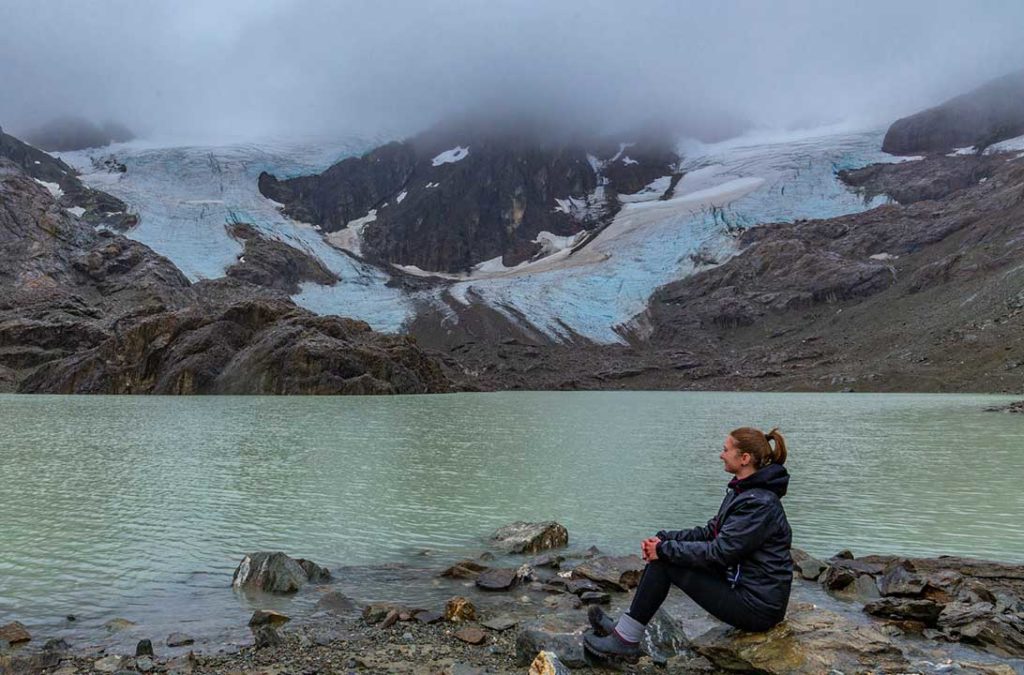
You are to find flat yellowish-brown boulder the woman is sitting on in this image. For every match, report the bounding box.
[693,603,910,675]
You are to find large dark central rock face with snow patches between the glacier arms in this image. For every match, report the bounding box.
[259,124,680,271]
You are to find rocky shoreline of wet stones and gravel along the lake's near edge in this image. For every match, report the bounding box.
[0,522,1024,675]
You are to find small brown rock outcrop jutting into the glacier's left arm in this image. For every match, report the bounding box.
[224,222,338,295]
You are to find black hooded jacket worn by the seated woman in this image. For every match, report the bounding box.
[657,464,793,621]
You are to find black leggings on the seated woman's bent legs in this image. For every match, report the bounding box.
[629,560,778,632]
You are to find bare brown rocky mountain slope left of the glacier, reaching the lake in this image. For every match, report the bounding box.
[0,151,450,393]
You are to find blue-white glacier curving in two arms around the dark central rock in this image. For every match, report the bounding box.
[60,129,904,343]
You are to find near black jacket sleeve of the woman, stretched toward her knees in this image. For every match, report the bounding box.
[657,500,775,568]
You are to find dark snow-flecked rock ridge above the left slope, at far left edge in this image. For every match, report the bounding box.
[0,130,138,231]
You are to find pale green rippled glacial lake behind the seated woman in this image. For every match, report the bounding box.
[0,392,1024,639]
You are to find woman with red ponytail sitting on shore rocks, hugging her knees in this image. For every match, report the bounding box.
[584,427,793,662]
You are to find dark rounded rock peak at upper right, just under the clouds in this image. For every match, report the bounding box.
[882,71,1024,155]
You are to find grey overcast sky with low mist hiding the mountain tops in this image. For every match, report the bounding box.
[0,0,1024,139]
